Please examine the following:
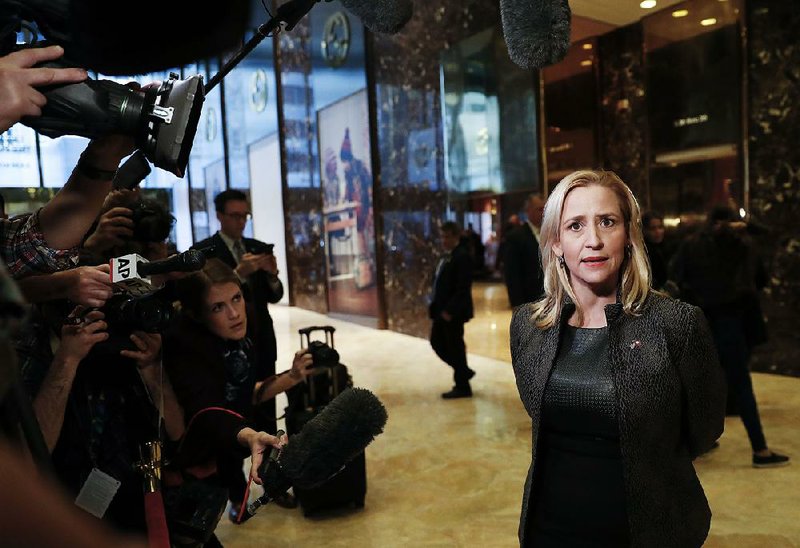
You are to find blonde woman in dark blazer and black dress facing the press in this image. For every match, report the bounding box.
[510,171,726,548]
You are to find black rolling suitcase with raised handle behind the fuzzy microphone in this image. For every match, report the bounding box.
[286,325,367,516]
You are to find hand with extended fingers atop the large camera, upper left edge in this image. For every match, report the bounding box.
[0,46,88,132]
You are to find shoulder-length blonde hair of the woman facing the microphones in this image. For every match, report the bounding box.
[533,170,650,329]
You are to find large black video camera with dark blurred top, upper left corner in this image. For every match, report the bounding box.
[0,0,250,177]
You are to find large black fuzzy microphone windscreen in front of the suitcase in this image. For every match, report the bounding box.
[279,388,387,489]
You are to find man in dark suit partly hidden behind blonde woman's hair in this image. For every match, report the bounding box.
[503,194,544,308]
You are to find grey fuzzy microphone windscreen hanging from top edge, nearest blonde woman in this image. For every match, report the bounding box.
[500,0,572,69]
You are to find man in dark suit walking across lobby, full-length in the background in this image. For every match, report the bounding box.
[428,221,475,399]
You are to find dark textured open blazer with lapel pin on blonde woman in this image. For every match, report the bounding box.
[510,292,726,548]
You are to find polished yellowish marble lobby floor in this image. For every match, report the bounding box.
[217,284,800,548]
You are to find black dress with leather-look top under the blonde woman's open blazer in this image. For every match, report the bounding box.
[527,326,630,548]
